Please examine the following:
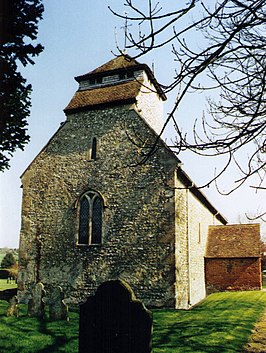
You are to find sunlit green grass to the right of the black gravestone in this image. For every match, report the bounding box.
[153,291,266,353]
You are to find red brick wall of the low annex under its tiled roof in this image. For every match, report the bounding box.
[205,258,261,293]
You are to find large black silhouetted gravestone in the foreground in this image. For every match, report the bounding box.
[79,281,152,353]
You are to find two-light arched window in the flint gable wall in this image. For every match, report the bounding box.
[78,191,103,245]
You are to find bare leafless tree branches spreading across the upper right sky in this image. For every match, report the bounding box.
[111,0,266,204]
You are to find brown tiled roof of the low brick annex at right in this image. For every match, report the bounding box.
[205,224,260,258]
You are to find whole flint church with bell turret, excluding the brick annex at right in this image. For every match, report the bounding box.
[18,56,226,308]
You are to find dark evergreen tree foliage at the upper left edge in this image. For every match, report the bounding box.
[0,0,43,171]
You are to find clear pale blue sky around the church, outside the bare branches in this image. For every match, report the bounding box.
[0,0,266,248]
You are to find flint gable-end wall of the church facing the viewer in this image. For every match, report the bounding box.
[18,106,179,308]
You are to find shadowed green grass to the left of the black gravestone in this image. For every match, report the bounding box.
[0,302,78,353]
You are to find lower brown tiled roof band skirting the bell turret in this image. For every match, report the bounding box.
[64,81,141,112]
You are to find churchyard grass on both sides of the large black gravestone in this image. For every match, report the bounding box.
[0,291,266,353]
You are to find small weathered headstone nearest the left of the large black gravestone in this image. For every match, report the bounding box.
[48,286,68,320]
